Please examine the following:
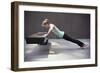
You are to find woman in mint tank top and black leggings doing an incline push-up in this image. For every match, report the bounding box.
[42,19,87,48]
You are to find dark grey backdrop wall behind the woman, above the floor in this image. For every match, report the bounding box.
[24,11,90,38]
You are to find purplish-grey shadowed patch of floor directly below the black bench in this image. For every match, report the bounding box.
[24,43,51,61]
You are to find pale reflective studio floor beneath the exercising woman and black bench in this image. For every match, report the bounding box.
[24,39,90,62]
